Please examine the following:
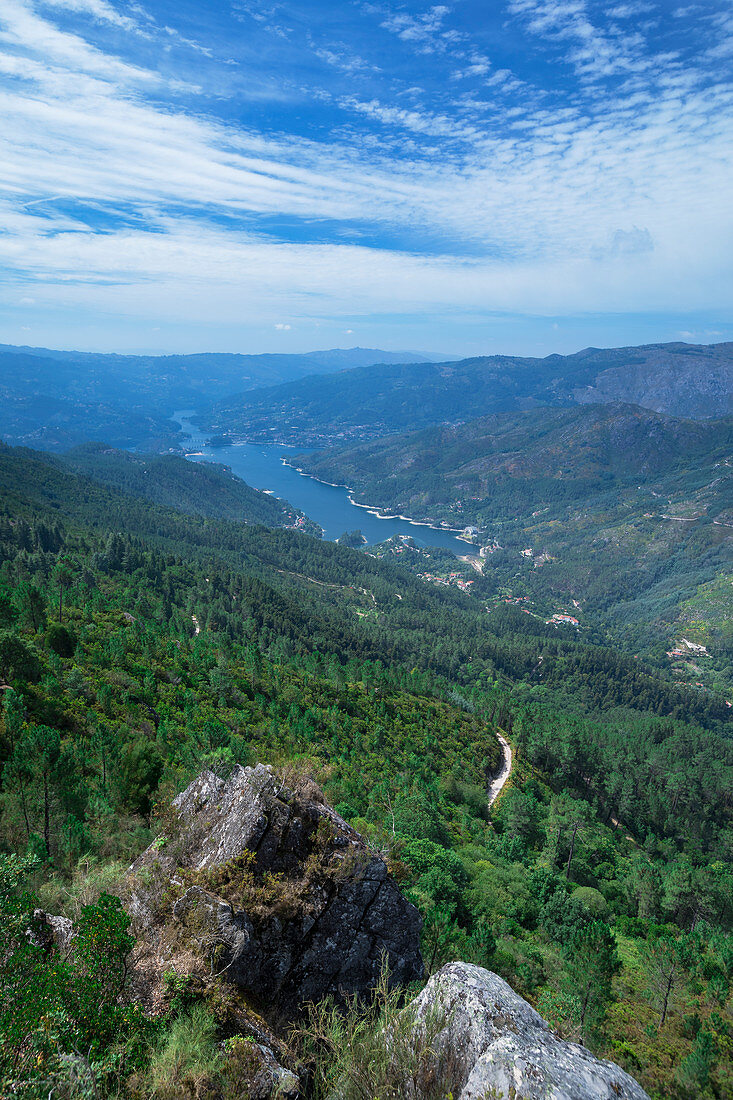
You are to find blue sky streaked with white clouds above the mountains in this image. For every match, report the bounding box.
[0,0,733,355]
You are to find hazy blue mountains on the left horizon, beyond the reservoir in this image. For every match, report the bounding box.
[0,344,444,451]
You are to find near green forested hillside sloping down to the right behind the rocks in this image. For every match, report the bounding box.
[0,448,733,1100]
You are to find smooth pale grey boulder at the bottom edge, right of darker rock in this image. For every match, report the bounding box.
[408,963,649,1100]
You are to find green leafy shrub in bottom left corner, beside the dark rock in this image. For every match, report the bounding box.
[0,856,150,1098]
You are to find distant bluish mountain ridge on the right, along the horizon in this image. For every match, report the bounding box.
[201,343,733,447]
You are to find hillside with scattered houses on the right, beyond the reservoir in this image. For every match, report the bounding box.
[293,405,733,691]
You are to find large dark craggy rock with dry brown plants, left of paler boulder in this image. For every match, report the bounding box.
[129,765,423,1022]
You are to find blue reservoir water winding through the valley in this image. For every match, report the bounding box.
[173,409,471,554]
